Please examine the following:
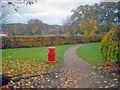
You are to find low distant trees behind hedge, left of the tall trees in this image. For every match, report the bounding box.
[3,19,62,36]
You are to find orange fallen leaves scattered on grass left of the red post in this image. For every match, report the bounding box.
[2,59,48,75]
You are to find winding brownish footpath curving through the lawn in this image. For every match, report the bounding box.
[59,44,118,88]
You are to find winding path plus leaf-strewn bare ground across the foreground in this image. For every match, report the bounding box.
[1,44,118,88]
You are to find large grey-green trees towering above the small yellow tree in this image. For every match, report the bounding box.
[71,2,119,34]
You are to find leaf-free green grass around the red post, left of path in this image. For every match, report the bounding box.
[2,45,70,62]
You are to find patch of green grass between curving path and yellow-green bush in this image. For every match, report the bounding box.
[76,43,102,66]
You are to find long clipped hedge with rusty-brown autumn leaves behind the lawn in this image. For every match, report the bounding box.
[2,35,102,49]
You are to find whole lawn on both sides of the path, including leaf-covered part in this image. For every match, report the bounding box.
[2,43,101,75]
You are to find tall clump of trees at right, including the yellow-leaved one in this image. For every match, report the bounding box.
[62,2,120,35]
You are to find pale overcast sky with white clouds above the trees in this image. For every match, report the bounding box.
[4,0,100,25]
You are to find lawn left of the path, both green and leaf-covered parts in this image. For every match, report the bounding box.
[2,45,71,74]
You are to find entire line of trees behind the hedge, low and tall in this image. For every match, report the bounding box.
[2,2,120,36]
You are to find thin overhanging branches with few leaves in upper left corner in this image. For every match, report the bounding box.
[0,0,38,23]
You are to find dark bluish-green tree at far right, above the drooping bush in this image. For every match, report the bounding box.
[98,2,118,32]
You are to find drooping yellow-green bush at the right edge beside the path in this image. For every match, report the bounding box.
[100,26,119,64]
